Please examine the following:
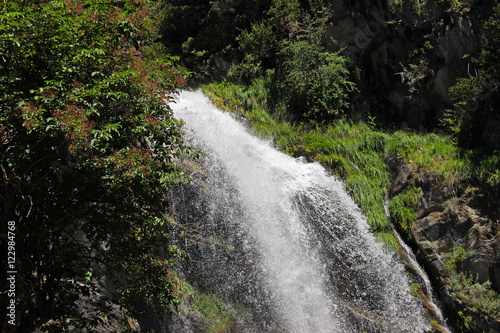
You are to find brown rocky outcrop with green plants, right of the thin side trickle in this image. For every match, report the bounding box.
[390,160,500,332]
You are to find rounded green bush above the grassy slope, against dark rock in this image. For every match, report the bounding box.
[275,35,356,120]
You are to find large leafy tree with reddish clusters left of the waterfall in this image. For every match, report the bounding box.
[0,0,192,332]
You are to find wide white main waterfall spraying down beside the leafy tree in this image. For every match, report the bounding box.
[170,91,430,333]
